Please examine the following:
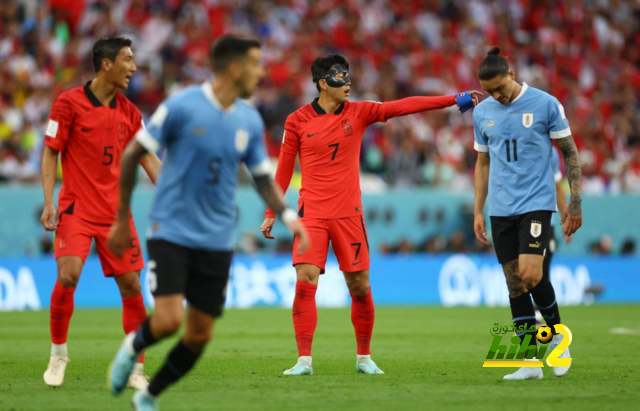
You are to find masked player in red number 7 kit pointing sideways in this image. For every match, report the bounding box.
[260,54,481,375]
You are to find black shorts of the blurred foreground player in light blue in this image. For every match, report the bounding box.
[147,240,233,317]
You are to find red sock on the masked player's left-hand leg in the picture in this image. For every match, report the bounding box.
[293,281,318,357]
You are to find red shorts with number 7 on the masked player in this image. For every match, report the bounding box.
[293,216,369,274]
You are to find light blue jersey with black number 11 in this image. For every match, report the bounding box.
[473,83,571,217]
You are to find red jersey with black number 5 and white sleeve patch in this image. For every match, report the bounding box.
[44,82,142,224]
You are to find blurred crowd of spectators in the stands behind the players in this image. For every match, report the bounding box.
[0,0,640,194]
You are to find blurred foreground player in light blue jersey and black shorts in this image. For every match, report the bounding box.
[108,36,308,411]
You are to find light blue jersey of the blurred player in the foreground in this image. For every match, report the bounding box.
[136,82,270,251]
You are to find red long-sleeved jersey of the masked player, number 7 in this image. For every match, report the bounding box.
[266,96,456,219]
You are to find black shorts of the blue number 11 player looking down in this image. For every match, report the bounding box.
[491,210,551,264]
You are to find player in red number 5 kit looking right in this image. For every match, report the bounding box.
[40,37,160,388]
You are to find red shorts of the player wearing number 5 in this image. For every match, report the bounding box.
[54,214,144,277]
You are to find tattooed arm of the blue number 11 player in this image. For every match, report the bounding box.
[556,136,582,236]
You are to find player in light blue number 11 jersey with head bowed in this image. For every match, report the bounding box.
[473,47,582,380]
